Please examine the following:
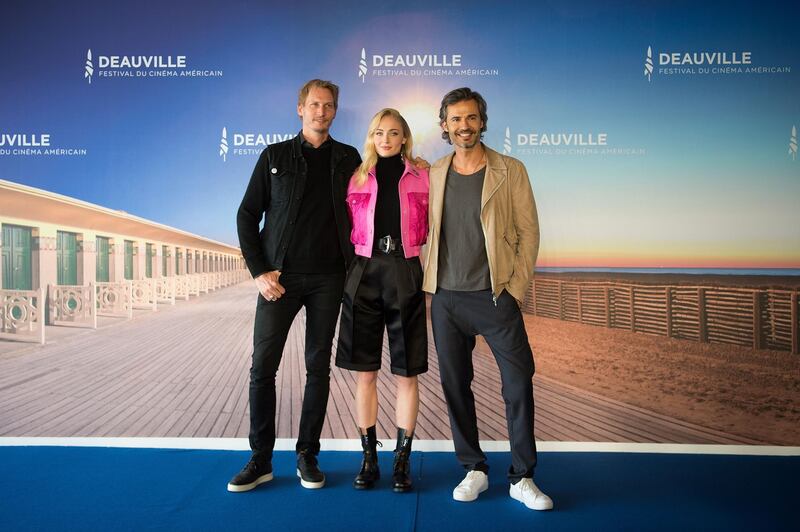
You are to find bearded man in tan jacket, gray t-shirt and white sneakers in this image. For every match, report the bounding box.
[423,88,553,510]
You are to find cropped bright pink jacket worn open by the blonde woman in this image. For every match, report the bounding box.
[347,161,429,259]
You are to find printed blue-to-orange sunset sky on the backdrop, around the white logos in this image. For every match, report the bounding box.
[0,1,800,267]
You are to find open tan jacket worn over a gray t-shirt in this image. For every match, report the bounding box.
[422,146,539,301]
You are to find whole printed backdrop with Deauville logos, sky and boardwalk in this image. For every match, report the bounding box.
[0,0,800,446]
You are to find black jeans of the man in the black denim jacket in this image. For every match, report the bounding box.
[250,273,344,460]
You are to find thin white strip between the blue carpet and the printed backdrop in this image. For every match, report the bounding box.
[0,437,800,456]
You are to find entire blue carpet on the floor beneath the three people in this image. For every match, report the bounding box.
[0,447,800,531]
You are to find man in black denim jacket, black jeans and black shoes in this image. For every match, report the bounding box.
[228,79,361,492]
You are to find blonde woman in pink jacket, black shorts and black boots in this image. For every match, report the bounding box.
[336,109,429,492]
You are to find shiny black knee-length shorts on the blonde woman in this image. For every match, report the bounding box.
[336,251,428,377]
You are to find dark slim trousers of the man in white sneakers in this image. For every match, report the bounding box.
[431,288,536,482]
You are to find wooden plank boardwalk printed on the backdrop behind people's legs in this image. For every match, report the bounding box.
[0,282,758,444]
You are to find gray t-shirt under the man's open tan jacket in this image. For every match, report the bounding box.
[438,166,492,292]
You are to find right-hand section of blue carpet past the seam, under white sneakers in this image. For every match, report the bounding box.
[417,453,800,531]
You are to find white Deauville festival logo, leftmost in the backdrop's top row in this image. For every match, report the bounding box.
[83,48,223,85]
